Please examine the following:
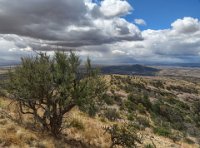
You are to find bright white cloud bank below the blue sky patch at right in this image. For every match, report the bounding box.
[78,17,200,64]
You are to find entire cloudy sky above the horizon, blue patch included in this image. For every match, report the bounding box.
[0,0,200,65]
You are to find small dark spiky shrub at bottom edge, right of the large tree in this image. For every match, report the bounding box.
[105,123,142,148]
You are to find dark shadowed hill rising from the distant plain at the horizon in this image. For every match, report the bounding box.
[100,64,160,76]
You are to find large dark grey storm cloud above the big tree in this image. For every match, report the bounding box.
[0,0,141,47]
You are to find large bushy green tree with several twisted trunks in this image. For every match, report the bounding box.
[8,52,107,137]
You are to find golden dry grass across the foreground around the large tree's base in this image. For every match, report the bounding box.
[0,100,198,148]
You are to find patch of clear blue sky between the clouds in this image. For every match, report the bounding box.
[125,0,200,30]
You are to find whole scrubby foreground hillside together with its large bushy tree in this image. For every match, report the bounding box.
[0,52,200,148]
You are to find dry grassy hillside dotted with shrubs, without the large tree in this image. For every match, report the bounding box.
[0,75,200,148]
